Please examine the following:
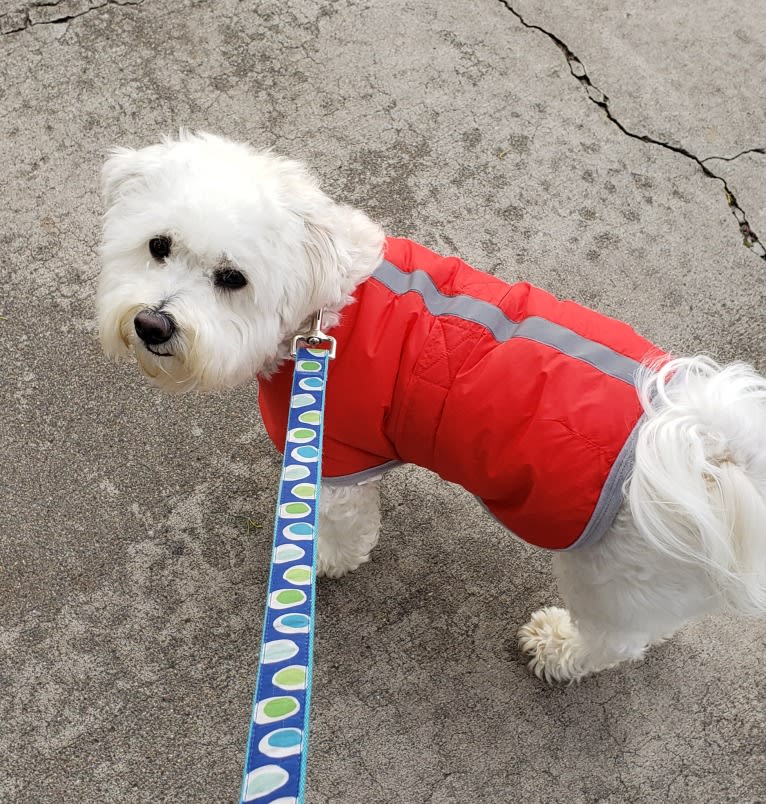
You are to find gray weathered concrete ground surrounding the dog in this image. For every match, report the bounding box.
[0,0,766,804]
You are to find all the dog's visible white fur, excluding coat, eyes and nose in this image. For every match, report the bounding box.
[97,134,766,682]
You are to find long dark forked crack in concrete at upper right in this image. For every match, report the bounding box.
[499,0,766,260]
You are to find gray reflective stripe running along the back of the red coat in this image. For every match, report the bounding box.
[373,260,640,385]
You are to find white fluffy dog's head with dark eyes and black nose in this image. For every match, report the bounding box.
[97,134,383,392]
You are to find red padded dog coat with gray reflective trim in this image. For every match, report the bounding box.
[260,238,662,549]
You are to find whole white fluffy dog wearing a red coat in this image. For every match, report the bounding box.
[97,134,766,682]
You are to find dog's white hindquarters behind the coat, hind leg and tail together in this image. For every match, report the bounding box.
[519,357,766,681]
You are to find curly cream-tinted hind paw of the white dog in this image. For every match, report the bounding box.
[518,606,585,684]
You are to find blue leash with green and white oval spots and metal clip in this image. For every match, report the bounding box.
[240,310,335,804]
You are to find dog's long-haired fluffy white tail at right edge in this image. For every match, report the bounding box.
[629,357,766,614]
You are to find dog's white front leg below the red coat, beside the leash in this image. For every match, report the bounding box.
[317,480,380,578]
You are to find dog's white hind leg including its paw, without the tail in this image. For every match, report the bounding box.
[519,506,716,683]
